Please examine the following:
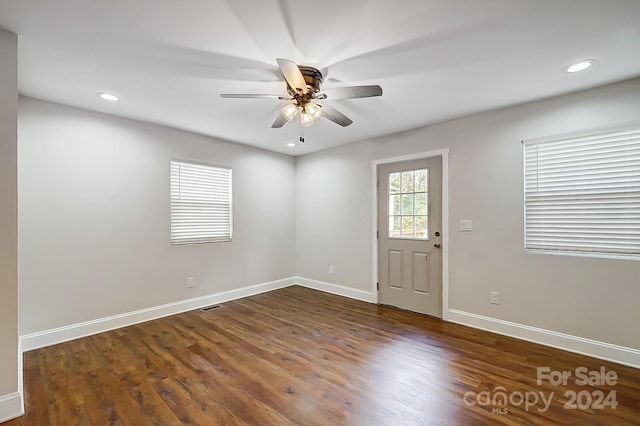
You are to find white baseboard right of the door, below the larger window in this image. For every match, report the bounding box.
[444,309,640,368]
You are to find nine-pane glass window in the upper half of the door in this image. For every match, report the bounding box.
[388,169,429,240]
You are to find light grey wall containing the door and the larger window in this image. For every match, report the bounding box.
[296,79,640,349]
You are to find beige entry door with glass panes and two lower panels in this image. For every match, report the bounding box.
[378,157,442,317]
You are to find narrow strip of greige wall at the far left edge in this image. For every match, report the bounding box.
[0,29,22,422]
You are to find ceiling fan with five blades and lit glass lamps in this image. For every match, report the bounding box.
[220,58,382,128]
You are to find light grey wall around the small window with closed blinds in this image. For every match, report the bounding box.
[18,98,295,335]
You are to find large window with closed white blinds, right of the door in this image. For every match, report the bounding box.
[523,122,640,256]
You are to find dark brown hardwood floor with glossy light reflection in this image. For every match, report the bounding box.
[3,287,640,426]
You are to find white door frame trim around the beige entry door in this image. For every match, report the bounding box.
[371,148,449,320]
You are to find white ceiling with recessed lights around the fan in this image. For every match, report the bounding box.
[0,0,640,155]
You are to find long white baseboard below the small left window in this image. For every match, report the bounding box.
[20,277,296,352]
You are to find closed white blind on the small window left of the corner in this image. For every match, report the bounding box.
[171,160,232,245]
